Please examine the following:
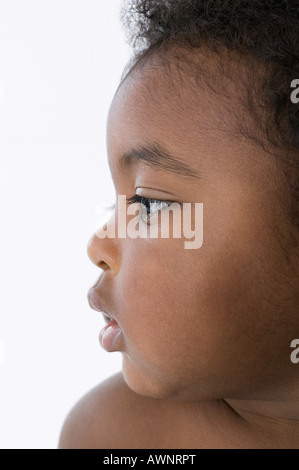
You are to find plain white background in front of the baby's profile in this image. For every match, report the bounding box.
[0,0,130,449]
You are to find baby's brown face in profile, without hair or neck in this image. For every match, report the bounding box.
[88,56,299,400]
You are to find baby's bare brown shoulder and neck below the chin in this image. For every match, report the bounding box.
[59,374,298,449]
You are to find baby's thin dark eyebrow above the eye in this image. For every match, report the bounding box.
[119,144,198,178]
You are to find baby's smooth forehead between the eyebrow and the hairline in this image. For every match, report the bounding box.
[107,55,278,185]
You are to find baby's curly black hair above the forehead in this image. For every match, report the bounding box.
[121,0,299,229]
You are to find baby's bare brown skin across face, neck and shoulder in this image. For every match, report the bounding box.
[60,50,299,449]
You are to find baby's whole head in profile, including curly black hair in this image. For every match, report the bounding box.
[88,0,299,400]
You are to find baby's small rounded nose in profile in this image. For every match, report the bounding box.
[87,222,119,273]
